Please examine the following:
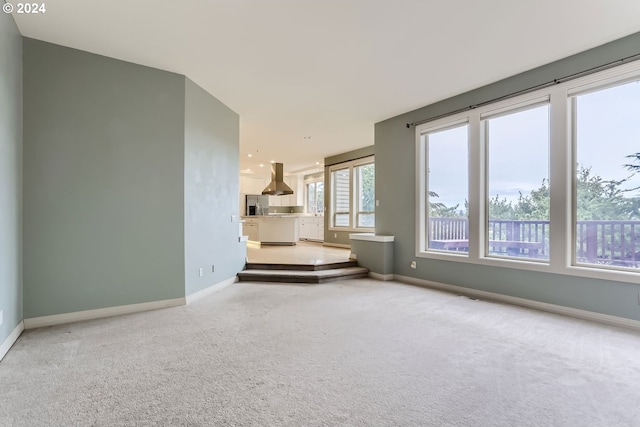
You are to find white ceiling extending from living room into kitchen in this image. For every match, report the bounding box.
[8,0,640,173]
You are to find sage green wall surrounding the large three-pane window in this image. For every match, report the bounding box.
[375,33,640,320]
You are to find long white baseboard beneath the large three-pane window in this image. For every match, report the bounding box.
[394,274,640,331]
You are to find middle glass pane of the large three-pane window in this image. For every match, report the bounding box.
[482,101,550,260]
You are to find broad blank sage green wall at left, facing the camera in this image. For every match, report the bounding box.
[23,38,185,318]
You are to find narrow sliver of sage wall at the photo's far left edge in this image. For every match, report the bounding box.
[0,13,22,344]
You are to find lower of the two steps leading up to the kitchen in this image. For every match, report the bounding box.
[238,267,369,283]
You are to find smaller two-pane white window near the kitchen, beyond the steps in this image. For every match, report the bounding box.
[330,158,375,229]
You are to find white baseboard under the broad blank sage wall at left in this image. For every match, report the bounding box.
[24,298,185,329]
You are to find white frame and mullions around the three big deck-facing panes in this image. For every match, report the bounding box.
[415,61,640,284]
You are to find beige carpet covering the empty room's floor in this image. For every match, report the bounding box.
[0,279,640,427]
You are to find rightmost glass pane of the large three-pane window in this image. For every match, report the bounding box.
[572,81,640,269]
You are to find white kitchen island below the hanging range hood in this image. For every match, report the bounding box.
[242,215,299,245]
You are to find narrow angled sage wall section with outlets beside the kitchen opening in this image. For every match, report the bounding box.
[184,79,246,295]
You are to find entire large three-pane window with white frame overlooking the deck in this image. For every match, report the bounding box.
[416,61,640,283]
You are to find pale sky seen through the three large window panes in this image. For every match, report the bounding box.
[429,81,640,212]
